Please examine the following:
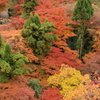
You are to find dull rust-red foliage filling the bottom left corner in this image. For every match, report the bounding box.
[0,77,36,100]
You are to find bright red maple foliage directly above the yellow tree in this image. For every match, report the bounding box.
[42,47,81,74]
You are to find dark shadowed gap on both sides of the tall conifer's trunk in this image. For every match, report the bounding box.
[66,30,95,56]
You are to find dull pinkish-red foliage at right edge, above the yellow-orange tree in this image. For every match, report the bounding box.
[80,52,100,80]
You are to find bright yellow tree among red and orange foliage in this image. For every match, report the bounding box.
[48,65,91,97]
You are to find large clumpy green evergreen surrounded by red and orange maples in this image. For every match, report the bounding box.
[22,14,57,55]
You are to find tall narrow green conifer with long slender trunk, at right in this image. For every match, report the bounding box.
[72,0,94,58]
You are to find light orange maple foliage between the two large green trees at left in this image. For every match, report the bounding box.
[1,30,38,62]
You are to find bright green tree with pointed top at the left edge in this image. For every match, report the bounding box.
[0,36,31,82]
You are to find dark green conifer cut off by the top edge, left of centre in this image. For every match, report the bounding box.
[21,0,39,19]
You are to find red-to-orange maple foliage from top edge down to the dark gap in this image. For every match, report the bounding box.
[35,0,75,51]
